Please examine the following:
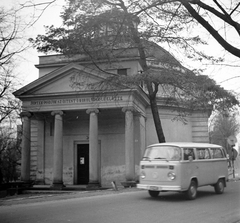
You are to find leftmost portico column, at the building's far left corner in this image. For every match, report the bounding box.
[21,112,31,183]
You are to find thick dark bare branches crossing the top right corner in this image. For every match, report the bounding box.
[179,0,240,58]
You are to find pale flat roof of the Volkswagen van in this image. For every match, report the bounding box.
[148,142,221,148]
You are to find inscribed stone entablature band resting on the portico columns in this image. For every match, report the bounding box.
[20,92,146,116]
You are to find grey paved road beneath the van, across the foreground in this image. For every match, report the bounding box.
[0,181,240,223]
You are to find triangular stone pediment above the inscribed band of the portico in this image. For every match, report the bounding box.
[14,63,114,96]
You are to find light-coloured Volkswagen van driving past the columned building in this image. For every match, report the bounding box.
[137,142,228,199]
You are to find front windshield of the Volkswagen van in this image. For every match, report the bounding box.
[143,146,181,161]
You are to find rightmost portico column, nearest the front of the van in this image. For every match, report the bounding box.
[122,107,135,186]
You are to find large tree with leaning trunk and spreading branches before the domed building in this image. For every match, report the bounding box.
[32,0,238,142]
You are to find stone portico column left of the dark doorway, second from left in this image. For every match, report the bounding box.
[51,111,63,190]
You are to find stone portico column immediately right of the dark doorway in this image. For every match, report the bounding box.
[87,109,100,188]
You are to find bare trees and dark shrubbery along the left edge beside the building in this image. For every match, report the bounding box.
[0,4,39,183]
